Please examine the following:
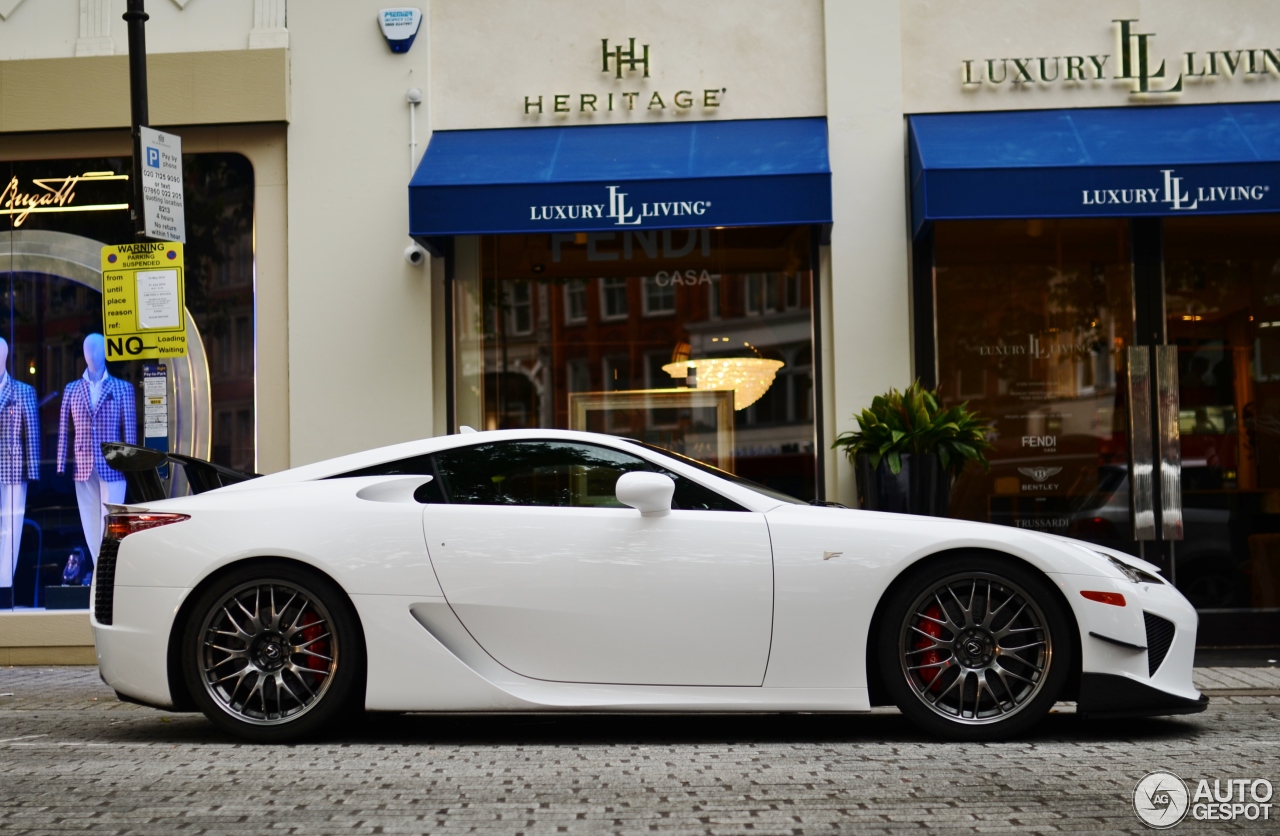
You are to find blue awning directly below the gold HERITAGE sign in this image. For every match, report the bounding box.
[408,119,831,239]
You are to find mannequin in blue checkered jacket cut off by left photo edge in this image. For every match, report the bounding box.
[0,338,40,607]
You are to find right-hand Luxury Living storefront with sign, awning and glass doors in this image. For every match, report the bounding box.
[904,3,1280,645]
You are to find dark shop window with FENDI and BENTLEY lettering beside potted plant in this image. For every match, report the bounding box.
[934,219,1135,551]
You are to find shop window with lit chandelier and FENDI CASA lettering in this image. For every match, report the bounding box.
[453,227,815,499]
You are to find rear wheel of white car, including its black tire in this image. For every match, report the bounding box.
[182,561,365,743]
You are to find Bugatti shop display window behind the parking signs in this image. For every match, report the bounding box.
[0,154,256,607]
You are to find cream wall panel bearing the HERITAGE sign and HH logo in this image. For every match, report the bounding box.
[430,0,824,131]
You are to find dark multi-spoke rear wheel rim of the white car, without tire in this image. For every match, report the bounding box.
[200,580,339,726]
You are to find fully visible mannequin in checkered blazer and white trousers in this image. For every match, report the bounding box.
[58,334,138,565]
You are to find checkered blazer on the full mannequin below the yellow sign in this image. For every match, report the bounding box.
[58,378,138,481]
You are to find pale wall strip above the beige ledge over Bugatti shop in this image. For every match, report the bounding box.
[0,0,257,60]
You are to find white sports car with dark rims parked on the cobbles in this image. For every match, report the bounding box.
[93,430,1207,741]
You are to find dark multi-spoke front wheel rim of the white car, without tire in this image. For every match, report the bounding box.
[899,572,1053,725]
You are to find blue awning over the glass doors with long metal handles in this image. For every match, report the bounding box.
[910,102,1280,232]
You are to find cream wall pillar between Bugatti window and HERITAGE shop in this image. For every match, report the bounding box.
[288,0,435,465]
